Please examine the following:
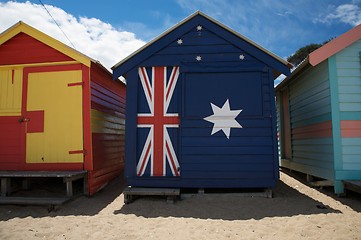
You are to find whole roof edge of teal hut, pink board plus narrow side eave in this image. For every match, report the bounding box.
[276,24,361,91]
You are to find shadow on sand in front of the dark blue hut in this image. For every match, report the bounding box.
[114,181,340,220]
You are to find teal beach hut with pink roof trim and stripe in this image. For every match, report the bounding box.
[276,25,361,194]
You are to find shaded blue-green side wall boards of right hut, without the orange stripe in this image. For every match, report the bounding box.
[281,61,334,179]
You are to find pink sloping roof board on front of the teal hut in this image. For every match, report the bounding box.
[309,24,361,66]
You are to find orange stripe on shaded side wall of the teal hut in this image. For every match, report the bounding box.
[292,121,332,139]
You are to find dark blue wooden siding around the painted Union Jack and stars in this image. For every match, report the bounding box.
[114,13,287,188]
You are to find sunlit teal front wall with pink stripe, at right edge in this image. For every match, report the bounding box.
[332,40,361,186]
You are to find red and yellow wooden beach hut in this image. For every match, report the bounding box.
[0,22,125,196]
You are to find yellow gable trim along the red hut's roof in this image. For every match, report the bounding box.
[0,21,93,67]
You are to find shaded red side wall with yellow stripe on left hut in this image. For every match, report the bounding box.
[89,64,125,195]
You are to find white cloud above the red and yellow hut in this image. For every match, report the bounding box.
[0,2,145,69]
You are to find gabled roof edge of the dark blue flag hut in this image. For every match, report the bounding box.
[112,11,292,77]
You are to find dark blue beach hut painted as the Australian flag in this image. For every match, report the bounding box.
[113,12,290,188]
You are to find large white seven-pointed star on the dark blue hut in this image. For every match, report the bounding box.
[204,99,243,139]
